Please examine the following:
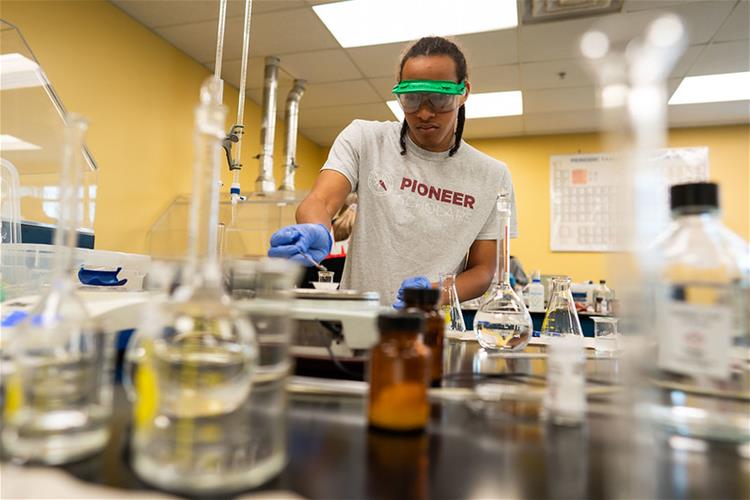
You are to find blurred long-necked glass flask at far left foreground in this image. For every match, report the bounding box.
[2,115,114,464]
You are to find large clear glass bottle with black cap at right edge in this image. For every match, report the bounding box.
[641,182,750,442]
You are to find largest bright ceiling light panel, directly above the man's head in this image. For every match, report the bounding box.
[313,0,518,48]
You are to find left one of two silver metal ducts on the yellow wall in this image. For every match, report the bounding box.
[255,56,280,193]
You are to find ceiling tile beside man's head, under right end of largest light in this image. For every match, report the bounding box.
[454,29,518,69]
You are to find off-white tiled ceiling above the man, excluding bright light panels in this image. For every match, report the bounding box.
[111,0,750,146]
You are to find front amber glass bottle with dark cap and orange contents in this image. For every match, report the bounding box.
[368,311,431,432]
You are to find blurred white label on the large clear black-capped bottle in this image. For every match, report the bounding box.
[658,300,732,380]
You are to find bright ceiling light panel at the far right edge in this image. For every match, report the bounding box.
[669,71,750,104]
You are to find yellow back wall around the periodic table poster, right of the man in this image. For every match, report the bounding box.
[469,125,750,281]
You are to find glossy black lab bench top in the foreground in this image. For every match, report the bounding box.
[3,340,750,499]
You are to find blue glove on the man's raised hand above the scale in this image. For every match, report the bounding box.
[268,224,333,266]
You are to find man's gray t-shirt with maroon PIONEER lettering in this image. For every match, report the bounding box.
[321,120,517,304]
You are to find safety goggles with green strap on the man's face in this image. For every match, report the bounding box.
[393,80,466,113]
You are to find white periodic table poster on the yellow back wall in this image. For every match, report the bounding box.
[550,147,708,252]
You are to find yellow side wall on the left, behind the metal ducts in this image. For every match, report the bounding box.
[0,0,324,252]
